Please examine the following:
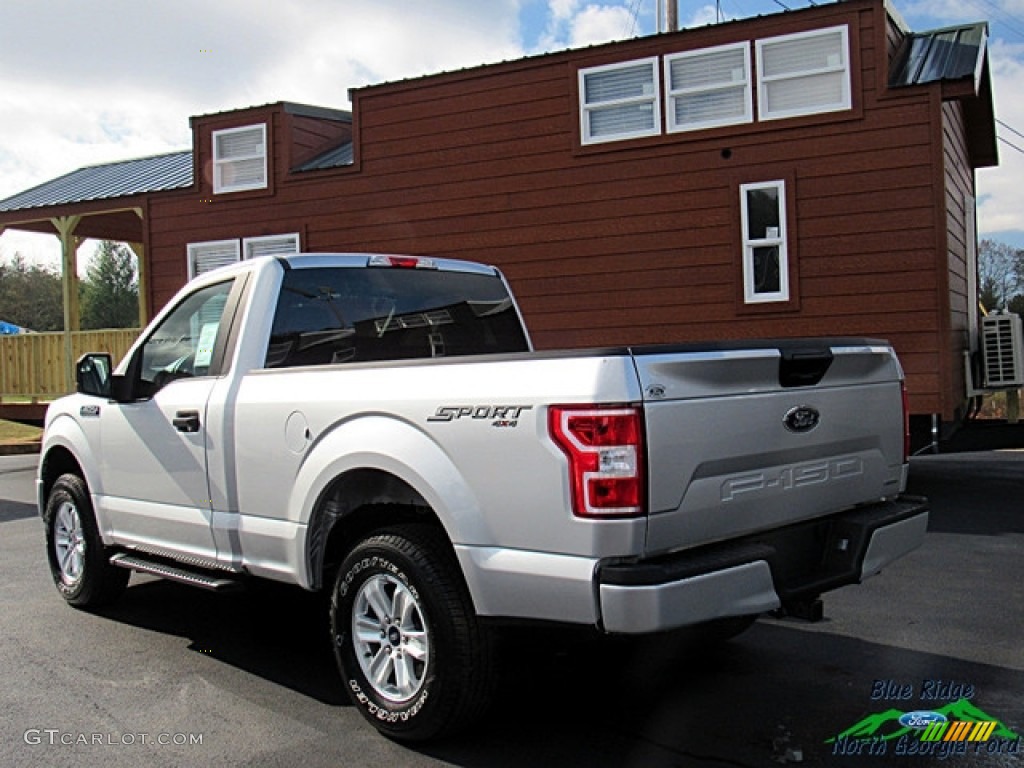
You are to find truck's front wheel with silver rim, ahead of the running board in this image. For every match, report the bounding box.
[43,474,131,608]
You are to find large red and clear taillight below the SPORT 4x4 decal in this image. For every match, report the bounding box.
[548,406,644,517]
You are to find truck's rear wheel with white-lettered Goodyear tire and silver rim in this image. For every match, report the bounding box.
[331,525,497,741]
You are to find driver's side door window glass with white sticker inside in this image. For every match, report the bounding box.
[139,281,233,395]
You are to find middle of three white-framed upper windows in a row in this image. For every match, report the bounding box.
[665,42,754,132]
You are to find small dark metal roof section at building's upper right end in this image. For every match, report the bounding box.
[889,22,988,87]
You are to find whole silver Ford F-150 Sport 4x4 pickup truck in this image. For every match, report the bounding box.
[37,254,928,740]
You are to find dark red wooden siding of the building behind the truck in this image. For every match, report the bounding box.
[140,0,963,418]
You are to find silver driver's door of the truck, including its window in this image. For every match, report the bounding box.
[97,280,237,564]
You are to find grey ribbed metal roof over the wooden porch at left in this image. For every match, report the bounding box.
[0,150,193,213]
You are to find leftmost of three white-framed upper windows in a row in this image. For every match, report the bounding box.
[580,57,662,144]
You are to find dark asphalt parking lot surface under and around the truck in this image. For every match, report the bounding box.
[0,452,1024,768]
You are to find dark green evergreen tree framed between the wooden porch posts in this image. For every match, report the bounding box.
[82,240,138,330]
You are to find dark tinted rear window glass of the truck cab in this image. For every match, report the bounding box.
[266,267,527,368]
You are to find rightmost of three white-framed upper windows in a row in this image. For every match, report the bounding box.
[757,26,851,120]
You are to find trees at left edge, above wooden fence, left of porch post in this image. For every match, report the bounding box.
[0,253,63,331]
